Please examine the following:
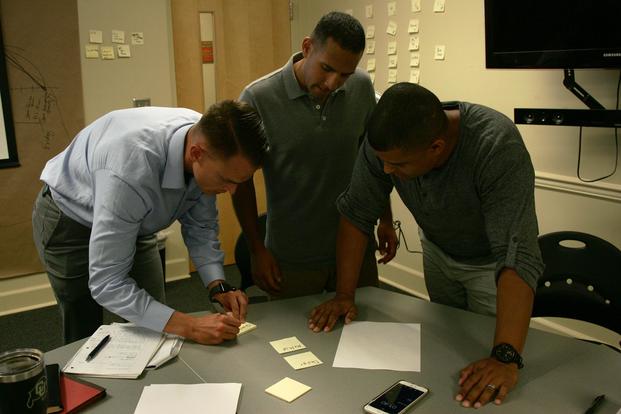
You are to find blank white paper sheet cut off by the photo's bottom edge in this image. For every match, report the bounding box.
[134,383,241,414]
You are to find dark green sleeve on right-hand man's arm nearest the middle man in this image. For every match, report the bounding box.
[336,139,393,235]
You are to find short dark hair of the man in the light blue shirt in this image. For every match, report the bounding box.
[198,100,269,167]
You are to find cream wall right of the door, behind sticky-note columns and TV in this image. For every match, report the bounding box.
[291,0,621,342]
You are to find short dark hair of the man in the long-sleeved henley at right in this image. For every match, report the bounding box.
[367,82,448,151]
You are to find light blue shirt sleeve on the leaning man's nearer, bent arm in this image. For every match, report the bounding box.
[89,169,173,331]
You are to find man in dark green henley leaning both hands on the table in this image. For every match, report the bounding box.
[309,83,543,408]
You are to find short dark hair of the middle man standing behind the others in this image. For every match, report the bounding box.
[311,11,365,53]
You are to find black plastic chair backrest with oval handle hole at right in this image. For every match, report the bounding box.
[533,231,621,334]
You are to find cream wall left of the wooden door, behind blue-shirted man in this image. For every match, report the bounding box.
[0,0,189,316]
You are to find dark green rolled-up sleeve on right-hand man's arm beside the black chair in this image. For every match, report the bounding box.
[478,137,543,291]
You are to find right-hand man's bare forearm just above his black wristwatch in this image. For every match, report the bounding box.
[494,268,534,353]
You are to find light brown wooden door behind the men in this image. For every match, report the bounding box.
[171,0,291,264]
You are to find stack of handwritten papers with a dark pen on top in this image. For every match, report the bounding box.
[63,324,173,378]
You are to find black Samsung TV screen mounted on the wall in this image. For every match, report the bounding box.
[485,0,621,69]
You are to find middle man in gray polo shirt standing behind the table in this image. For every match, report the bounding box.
[233,12,396,297]
